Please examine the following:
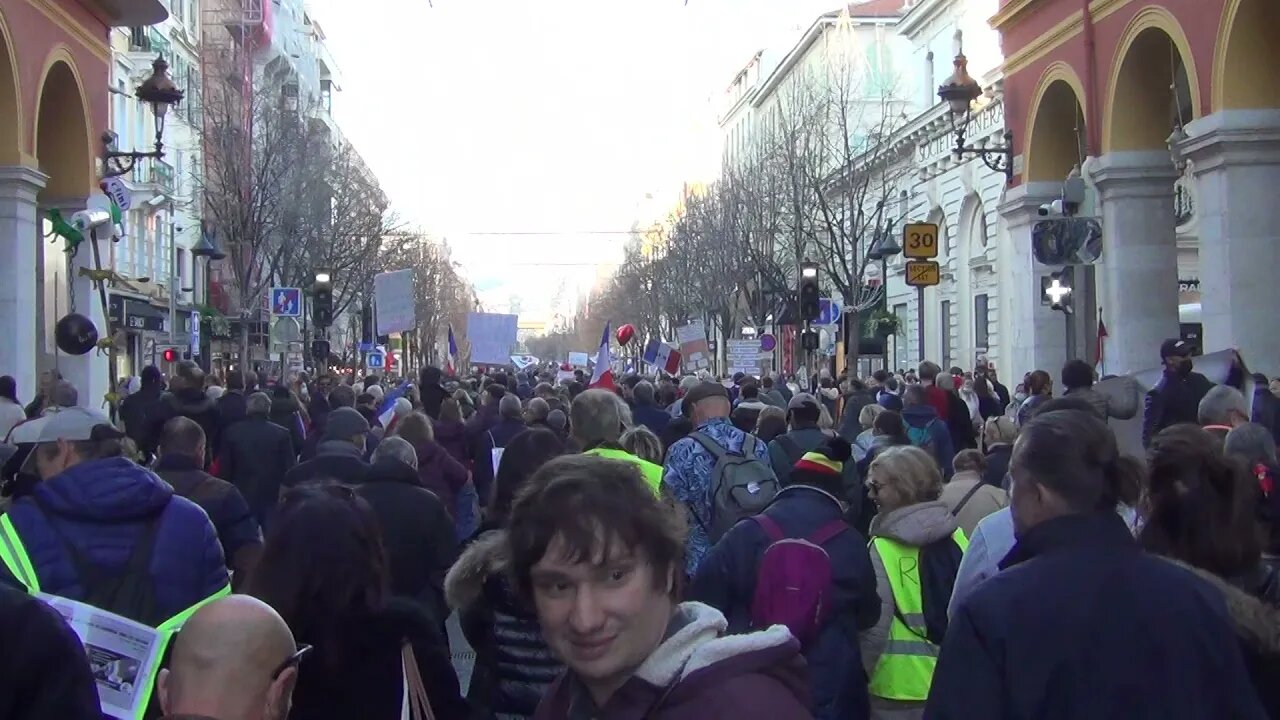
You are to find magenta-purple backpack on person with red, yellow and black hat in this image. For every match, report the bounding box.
[751,515,849,646]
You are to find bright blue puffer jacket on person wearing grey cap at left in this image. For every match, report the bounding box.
[0,457,228,618]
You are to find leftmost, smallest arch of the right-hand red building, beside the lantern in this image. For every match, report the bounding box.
[1023,61,1085,182]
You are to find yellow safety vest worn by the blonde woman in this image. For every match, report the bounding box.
[868,528,969,702]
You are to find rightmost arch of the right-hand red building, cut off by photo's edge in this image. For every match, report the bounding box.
[1212,0,1280,113]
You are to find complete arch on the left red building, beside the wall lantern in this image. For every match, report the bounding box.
[33,47,95,200]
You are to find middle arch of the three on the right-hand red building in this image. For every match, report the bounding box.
[1102,5,1201,152]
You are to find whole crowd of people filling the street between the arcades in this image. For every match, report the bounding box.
[0,341,1280,720]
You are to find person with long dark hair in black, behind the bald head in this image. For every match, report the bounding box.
[248,484,470,720]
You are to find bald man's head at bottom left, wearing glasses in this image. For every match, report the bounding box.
[157,594,297,720]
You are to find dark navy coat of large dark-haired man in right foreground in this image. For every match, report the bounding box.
[924,510,1266,720]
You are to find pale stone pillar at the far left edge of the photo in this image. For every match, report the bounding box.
[0,165,49,401]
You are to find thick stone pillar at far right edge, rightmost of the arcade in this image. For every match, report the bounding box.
[1181,110,1280,377]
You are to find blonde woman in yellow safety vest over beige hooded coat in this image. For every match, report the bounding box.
[859,446,969,720]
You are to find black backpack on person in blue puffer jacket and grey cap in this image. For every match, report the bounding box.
[32,495,168,628]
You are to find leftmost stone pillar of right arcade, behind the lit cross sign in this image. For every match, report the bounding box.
[996,182,1066,376]
